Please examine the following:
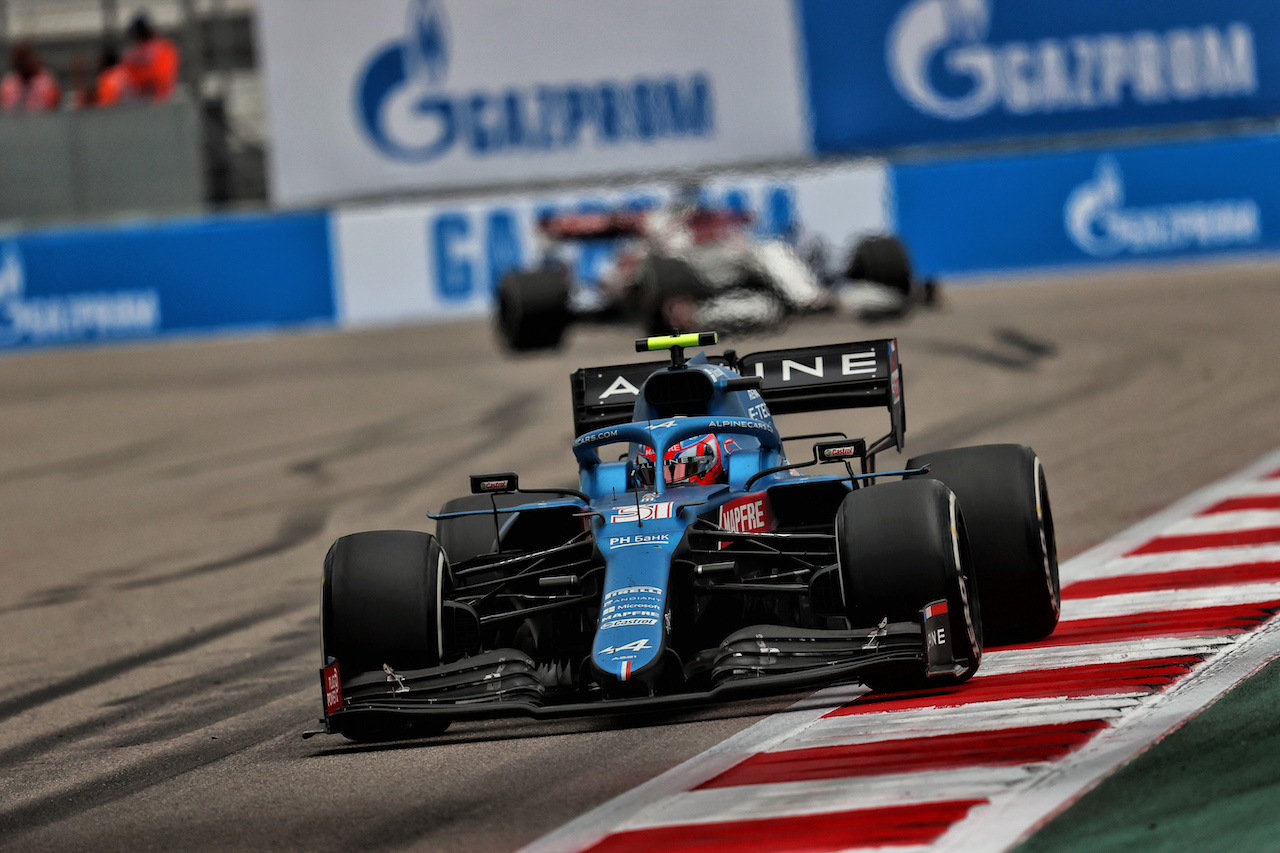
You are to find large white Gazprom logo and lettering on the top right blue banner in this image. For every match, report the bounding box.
[886,0,1258,122]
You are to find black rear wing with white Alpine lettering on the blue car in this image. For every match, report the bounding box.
[570,338,906,451]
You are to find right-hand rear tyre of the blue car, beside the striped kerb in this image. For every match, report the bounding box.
[908,444,1061,644]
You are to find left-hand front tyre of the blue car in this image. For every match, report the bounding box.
[320,530,449,740]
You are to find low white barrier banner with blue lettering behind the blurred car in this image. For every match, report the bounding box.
[333,163,892,325]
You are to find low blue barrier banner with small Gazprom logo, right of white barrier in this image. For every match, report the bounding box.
[892,136,1280,275]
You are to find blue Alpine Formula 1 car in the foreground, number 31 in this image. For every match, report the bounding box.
[314,333,1059,740]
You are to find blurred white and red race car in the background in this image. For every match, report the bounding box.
[494,194,936,351]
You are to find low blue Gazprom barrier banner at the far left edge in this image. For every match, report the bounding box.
[0,213,334,348]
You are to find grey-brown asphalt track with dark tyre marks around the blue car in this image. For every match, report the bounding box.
[0,261,1280,850]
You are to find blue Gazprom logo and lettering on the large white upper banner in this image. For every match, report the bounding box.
[356,0,716,163]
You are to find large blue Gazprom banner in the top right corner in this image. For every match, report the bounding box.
[797,0,1280,152]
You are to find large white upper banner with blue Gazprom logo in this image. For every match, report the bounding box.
[257,0,809,205]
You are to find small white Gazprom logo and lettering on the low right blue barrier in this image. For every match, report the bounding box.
[1062,155,1262,257]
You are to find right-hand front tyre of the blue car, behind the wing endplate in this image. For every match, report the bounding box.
[836,480,983,690]
